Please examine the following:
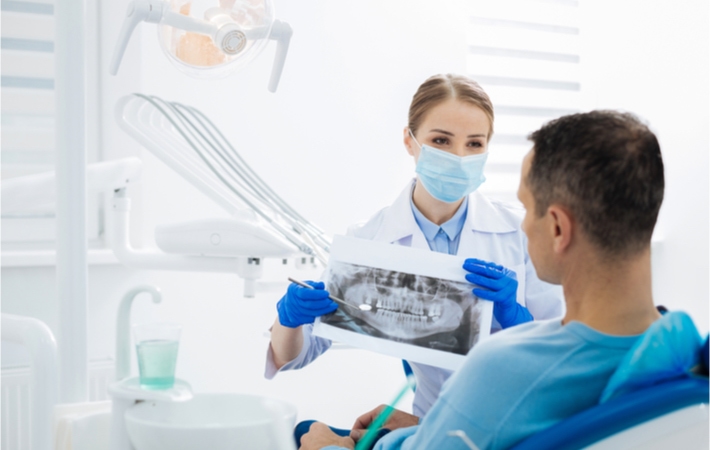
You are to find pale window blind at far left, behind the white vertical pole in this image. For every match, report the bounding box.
[0,0,101,246]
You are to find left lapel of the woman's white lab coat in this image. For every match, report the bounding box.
[374,180,429,250]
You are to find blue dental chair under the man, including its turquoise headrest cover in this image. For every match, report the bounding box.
[294,312,710,450]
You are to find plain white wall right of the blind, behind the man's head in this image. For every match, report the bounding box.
[581,0,710,333]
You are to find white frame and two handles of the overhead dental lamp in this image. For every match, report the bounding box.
[109,0,293,92]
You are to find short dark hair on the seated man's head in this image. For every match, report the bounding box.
[526,111,664,257]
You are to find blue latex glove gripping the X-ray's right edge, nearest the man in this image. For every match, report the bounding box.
[463,258,533,329]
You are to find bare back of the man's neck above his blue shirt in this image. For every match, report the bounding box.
[562,249,660,335]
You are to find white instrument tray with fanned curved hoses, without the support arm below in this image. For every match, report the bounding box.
[115,94,330,264]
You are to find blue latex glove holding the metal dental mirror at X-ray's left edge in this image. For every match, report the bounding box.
[276,281,338,328]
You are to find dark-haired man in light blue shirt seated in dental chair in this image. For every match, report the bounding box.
[301,111,664,450]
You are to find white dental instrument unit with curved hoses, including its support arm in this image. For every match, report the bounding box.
[109,94,330,297]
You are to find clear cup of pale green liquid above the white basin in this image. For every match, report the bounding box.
[133,323,181,391]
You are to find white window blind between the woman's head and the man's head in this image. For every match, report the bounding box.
[466,0,581,202]
